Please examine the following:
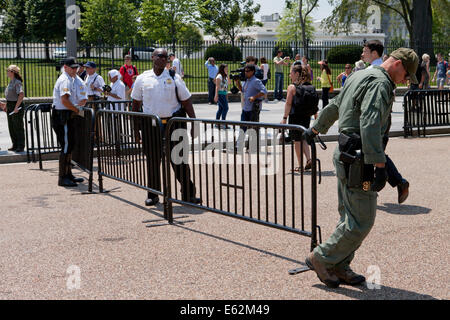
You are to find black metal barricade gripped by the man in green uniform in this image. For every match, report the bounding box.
[165,118,320,250]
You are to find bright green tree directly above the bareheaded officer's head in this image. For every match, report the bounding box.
[141,0,197,50]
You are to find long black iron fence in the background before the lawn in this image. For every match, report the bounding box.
[0,41,450,97]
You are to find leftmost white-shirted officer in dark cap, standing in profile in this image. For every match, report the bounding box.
[52,57,86,187]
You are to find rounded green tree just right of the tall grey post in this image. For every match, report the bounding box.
[80,0,138,48]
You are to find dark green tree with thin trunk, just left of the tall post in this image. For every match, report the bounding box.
[25,0,66,60]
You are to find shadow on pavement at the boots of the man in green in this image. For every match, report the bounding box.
[313,280,438,300]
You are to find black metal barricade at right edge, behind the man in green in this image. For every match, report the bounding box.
[403,90,450,138]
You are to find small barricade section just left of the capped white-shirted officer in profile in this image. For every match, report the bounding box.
[25,103,61,170]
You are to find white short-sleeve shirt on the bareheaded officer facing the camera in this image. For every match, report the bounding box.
[131,69,191,118]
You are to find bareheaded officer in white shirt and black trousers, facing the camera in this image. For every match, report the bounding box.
[131,48,201,206]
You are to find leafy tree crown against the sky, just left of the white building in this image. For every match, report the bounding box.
[198,0,261,47]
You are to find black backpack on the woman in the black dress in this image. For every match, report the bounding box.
[292,84,319,117]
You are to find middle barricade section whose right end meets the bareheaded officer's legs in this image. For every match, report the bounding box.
[95,109,166,217]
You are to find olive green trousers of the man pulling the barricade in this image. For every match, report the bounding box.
[314,147,377,269]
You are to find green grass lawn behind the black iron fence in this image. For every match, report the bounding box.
[0,58,435,97]
